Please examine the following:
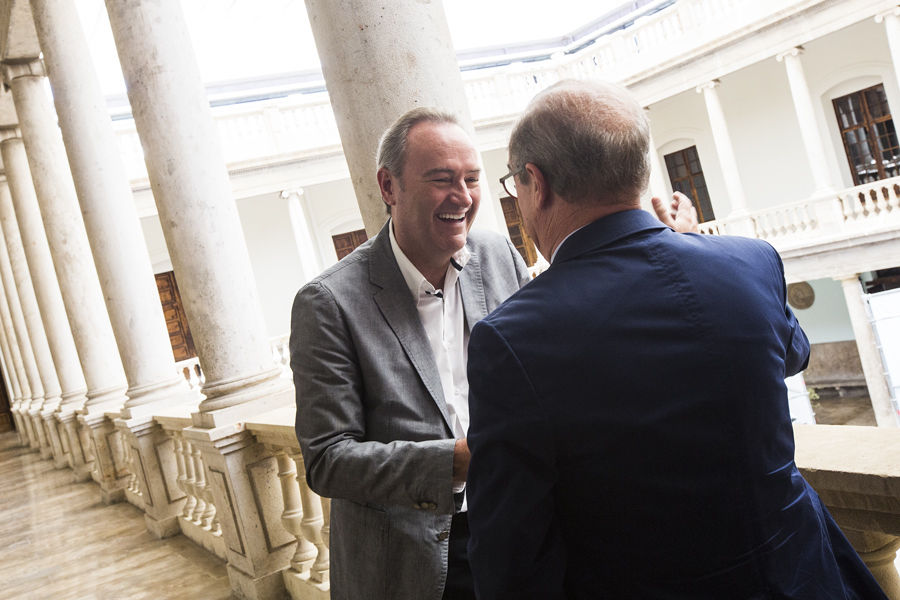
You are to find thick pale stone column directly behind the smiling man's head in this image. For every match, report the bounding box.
[306,0,478,238]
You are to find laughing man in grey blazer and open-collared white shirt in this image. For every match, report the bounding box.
[290,109,696,600]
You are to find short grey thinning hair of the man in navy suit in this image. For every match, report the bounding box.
[509,79,650,203]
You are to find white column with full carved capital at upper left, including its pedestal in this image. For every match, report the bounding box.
[4,59,127,503]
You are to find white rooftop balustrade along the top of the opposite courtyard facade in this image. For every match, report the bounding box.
[109,0,810,182]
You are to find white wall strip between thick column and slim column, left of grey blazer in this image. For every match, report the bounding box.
[236,194,305,338]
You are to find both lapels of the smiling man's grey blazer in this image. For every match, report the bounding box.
[369,220,487,431]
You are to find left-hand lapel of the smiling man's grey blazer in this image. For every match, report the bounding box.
[369,220,453,431]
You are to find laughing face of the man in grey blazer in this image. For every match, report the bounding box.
[378,122,481,283]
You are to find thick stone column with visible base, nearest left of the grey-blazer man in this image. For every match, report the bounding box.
[106,0,292,427]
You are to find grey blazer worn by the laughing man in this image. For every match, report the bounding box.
[290,225,529,600]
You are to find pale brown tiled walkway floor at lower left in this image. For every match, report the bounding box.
[0,433,230,600]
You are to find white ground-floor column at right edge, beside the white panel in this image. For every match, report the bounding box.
[835,274,897,427]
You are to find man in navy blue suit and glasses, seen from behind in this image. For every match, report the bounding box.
[468,81,886,600]
